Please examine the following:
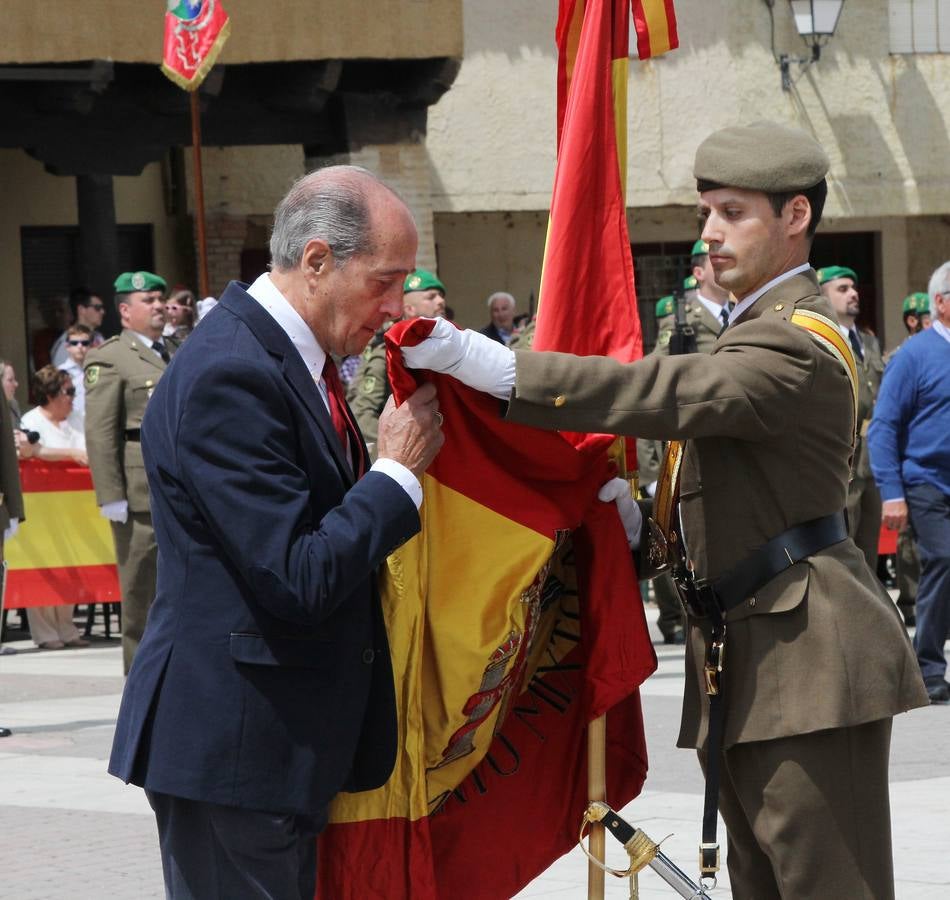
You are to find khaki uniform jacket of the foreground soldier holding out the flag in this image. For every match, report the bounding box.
[508,272,928,747]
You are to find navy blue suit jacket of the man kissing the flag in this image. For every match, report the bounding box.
[109,282,419,814]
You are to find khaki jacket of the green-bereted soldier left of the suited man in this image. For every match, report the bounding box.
[84,331,178,513]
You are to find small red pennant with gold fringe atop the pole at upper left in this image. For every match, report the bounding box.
[162,0,231,91]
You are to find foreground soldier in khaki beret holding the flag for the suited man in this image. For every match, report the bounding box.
[403,122,928,900]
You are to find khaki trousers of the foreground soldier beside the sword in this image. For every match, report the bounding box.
[700,719,894,900]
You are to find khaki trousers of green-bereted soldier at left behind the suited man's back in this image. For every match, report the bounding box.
[112,512,158,675]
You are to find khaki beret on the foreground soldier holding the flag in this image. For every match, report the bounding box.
[693,122,829,194]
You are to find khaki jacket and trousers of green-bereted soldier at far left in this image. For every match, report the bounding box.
[84,330,178,673]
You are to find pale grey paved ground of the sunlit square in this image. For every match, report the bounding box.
[0,610,950,900]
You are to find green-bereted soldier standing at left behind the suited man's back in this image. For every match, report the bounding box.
[84,272,178,674]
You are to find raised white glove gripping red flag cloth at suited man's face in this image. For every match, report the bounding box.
[402,319,515,400]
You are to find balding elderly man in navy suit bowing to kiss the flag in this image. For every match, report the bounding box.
[109,166,442,900]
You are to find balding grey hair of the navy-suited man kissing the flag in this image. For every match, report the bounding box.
[270,166,382,270]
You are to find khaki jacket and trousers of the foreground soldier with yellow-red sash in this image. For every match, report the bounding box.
[507,270,928,900]
